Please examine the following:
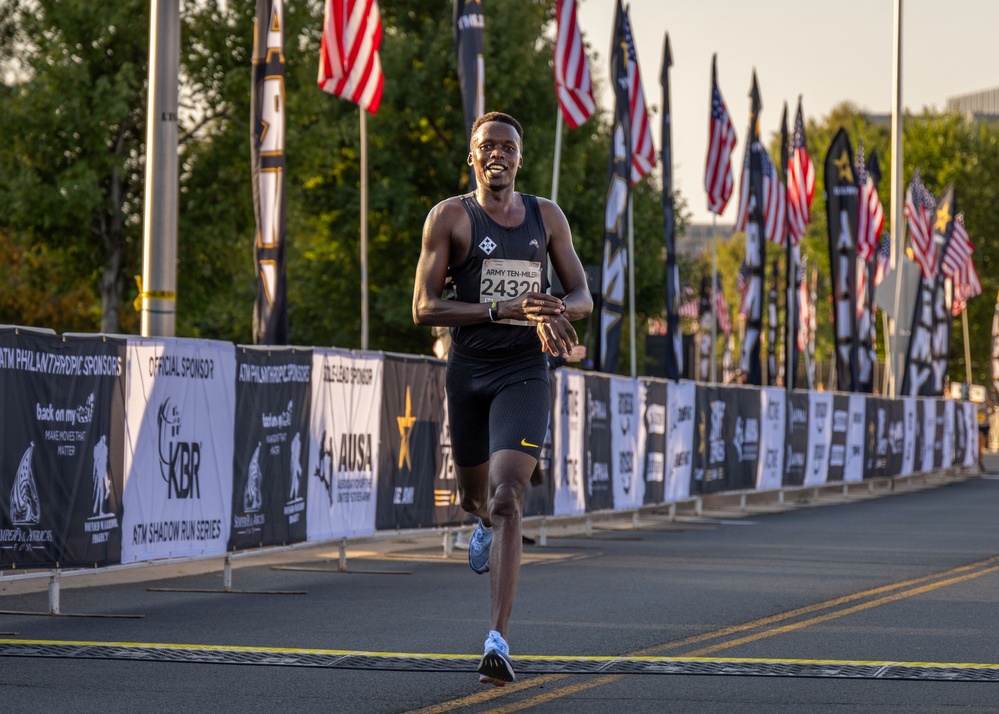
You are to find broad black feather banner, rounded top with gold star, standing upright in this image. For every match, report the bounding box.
[825,129,859,392]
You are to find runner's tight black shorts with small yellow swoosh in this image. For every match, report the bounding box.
[447,345,550,467]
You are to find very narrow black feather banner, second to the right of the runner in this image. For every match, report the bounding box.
[659,34,683,382]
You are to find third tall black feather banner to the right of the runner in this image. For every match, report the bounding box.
[739,71,764,385]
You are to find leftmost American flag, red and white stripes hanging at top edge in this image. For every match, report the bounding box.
[318,0,385,114]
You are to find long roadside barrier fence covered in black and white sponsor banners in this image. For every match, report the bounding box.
[0,328,978,570]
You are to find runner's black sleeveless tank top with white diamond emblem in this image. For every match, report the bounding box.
[448,193,548,350]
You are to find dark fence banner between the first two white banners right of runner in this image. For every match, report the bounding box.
[583,374,616,512]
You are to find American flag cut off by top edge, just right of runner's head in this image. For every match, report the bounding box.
[555,0,596,129]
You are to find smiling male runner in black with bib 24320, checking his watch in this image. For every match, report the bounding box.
[413,112,593,687]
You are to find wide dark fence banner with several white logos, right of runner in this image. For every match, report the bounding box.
[691,385,760,493]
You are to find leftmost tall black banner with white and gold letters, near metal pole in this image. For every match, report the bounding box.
[250,0,288,345]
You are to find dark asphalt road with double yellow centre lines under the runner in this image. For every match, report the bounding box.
[0,470,999,714]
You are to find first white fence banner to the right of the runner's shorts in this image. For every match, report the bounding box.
[552,368,586,516]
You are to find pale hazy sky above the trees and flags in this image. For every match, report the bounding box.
[577,0,999,224]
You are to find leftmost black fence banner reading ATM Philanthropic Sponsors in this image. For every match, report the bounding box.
[0,330,125,568]
